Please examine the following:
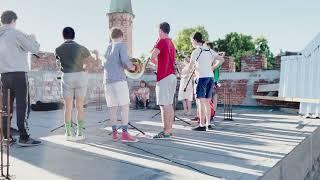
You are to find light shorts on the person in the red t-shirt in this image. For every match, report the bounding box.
[156,74,177,106]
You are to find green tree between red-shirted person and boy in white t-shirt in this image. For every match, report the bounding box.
[174,26,209,60]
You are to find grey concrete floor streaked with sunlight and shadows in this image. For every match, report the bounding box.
[3,107,318,180]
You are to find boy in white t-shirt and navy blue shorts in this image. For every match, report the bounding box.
[189,32,223,131]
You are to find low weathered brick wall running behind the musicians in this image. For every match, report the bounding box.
[25,53,299,107]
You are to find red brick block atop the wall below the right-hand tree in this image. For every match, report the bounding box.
[240,55,267,72]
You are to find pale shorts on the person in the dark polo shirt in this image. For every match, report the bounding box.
[61,72,88,98]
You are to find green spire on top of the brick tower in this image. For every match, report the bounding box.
[108,0,134,15]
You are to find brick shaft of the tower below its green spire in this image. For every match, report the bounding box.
[108,13,133,57]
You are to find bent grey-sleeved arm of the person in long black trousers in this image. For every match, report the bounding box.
[17,31,40,54]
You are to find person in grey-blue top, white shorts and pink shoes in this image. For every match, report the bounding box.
[102,28,138,142]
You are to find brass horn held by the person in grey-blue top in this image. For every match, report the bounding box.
[124,58,150,79]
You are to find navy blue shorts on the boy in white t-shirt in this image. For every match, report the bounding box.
[196,77,214,99]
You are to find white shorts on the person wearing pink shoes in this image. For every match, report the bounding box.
[104,81,130,107]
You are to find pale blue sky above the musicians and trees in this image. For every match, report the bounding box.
[0,0,320,57]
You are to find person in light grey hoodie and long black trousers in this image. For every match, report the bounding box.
[0,11,41,146]
